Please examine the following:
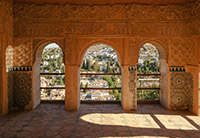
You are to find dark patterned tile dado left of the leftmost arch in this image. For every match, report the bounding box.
[8,66,32,111]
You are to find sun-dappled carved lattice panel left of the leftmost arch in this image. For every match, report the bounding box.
[14,39,32,66]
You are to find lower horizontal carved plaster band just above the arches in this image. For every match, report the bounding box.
[14,21,191,37]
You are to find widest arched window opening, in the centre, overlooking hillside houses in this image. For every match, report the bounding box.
[80,43,121,101]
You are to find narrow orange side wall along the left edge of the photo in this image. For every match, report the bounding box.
[0,0,13,114]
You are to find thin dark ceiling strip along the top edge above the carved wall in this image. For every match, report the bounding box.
[14,0,196,5]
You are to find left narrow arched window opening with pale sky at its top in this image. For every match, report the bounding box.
[40,43,65,100]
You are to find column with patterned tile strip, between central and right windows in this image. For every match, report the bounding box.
[122,65,137,110]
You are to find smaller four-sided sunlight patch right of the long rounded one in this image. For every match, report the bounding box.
[155,115,198,130]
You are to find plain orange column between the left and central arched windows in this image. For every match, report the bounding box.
[65,65,79,110]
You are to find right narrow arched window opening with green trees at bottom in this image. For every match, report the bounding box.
[137,43,160,100]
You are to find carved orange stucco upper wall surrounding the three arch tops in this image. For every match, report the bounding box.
[0,1,200,112]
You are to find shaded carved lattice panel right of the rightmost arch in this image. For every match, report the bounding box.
[170,38,195,65]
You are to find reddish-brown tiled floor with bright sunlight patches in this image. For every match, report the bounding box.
[0,104,200,138]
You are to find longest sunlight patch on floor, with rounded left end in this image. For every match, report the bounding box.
[81,113,160,128]
